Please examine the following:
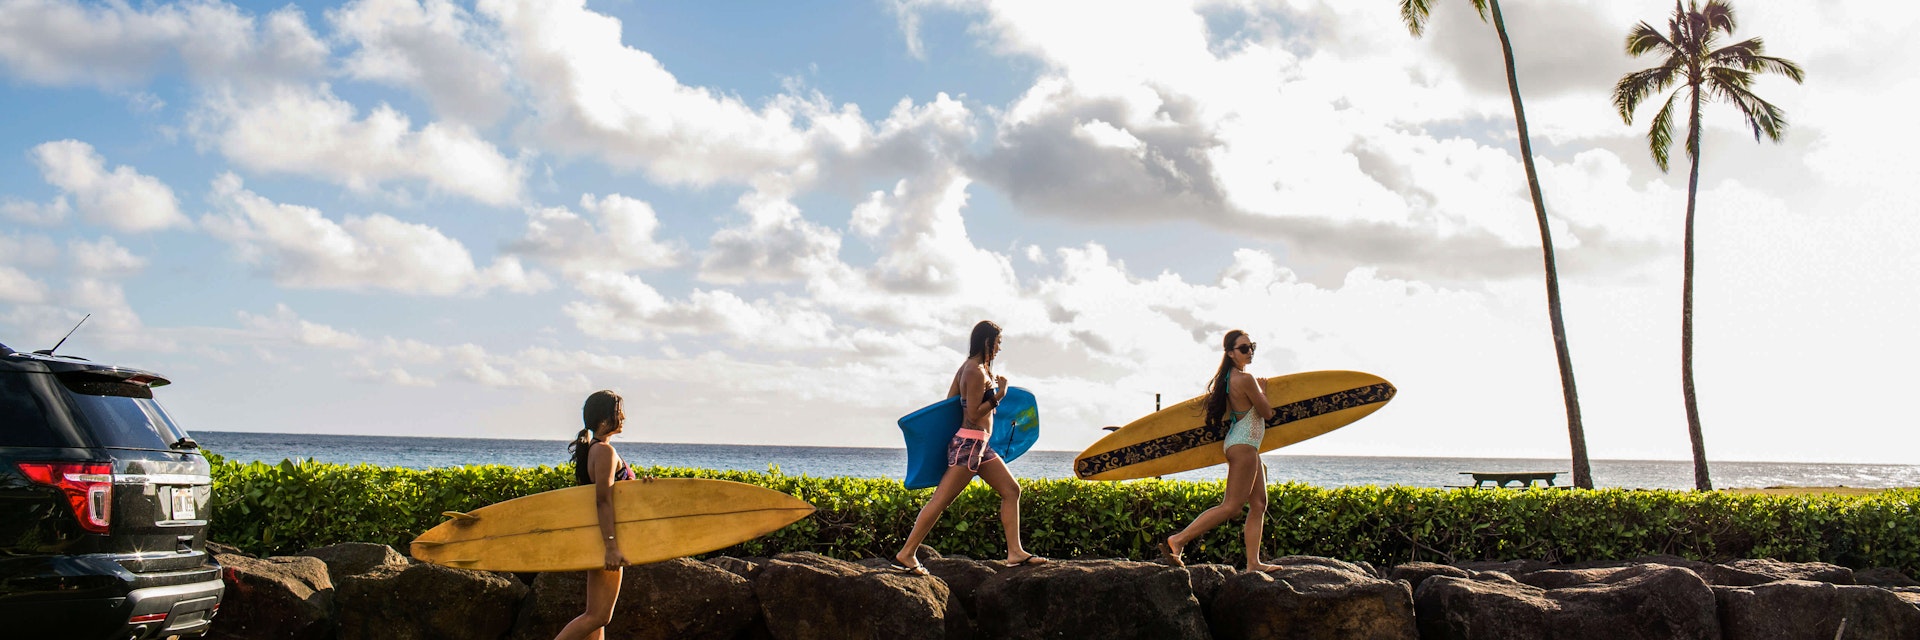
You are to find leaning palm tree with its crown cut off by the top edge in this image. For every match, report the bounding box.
[1400,0,1594,488]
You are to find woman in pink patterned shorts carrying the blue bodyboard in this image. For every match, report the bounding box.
[893,321,1046,575]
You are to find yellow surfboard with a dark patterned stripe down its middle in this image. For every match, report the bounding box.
[1073,371,1398,480]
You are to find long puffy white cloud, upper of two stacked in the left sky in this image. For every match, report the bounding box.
[192,85,526,206]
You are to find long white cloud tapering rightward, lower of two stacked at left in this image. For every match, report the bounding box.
[202,173,551,296]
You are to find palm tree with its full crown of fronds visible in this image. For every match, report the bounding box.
[1613,0,1807,492]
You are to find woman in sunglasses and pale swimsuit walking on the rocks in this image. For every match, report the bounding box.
[1160,329,1279,571]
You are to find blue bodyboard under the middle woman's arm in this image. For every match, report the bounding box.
[900,386,1041,488]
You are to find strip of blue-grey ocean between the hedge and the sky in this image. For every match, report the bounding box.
[183,431,1920,490]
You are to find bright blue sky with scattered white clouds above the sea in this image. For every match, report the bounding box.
[0,0,1920,463]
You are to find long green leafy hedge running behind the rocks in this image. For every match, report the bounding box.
[209,453,1920,575]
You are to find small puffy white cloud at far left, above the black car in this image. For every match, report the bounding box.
[33,140,190,231]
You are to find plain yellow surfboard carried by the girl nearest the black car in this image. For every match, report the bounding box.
[411,479,814,573]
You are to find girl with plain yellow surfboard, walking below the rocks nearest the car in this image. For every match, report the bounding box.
[553,390,634,640]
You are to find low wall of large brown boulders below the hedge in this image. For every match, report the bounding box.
[209,544,1920,640]
